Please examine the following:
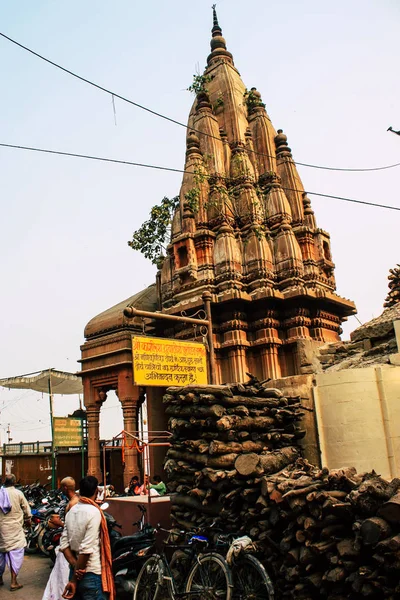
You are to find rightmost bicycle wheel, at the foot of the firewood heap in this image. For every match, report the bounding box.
[232,554,274,600]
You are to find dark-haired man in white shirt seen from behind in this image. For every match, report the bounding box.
[60,476,108,600]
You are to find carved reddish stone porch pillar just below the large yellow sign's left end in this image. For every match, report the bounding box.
[118,369,139,487]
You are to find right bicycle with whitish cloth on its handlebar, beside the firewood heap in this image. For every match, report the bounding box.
[215,533,275,600]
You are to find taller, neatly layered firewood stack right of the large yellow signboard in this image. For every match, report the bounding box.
[164,378,305,530]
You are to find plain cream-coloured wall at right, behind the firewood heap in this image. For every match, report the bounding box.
[314,366,400,479]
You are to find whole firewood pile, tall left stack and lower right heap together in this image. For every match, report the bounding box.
[164,381,400,600]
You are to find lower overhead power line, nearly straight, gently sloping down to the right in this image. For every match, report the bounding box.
[0,143,400,211]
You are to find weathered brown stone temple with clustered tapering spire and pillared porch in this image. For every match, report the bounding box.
[80,9,356,483]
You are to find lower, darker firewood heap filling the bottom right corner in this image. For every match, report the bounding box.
[237,458,400,599]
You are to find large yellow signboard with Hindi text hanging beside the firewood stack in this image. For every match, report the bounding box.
[132,336,208,387]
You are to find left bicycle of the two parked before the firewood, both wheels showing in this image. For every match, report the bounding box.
[133,527,233,600]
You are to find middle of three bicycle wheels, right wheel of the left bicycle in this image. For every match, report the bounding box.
[186,553,233,600]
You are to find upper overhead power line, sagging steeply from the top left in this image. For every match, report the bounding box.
[0,32,400,173]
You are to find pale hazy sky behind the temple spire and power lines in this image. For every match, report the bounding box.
[0,0,400,442]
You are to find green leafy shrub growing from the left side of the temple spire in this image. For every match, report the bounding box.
[128,196,179,265]
